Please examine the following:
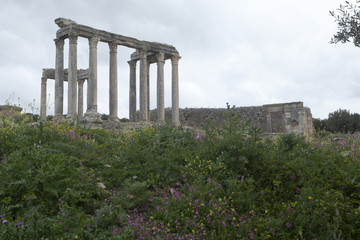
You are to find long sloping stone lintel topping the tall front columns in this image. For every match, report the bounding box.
[56,19,179,55]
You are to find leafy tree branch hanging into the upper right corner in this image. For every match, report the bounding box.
[330,0,360,47]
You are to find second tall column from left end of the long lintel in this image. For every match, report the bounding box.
[66,35,77,123]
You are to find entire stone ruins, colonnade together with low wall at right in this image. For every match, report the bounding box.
[40,18,314,136]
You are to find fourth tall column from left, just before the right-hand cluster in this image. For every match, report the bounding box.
[109,43,119,121]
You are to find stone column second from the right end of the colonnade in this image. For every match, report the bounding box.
[156,53,165,122]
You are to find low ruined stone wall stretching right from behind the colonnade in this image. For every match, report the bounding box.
[150,102,314,136]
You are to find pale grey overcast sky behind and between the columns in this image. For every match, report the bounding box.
[0,0,360,118]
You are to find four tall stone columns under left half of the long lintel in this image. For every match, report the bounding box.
[55,36,114,123]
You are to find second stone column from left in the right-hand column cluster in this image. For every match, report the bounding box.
[139,49,148,122]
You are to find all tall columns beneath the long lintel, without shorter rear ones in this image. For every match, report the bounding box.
[55,35,179,124]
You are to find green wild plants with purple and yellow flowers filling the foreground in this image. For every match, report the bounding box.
[0,106,360,239]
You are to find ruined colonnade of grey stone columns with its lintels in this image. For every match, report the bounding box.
[40,18,180,128]
